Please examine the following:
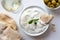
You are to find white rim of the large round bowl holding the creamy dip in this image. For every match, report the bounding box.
[19,6,49,36]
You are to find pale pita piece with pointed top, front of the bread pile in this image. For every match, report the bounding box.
[0,27,22,40]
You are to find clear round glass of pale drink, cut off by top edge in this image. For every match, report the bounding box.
[1,0,22,13]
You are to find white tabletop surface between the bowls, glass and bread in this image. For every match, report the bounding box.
[0,0,60,40]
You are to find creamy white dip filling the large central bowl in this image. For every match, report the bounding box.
[21,7,47,34]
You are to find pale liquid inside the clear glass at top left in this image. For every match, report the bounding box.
[2,0,21,12]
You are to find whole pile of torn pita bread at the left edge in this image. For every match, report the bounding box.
[0,14,21,40]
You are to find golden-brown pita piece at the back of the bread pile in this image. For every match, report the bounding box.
[0,14,17,30]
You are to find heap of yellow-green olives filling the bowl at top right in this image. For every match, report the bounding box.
[44,0,60,8]
